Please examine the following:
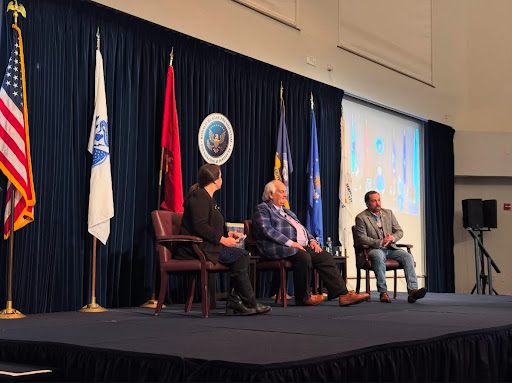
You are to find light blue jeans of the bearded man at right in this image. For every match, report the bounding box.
[368,248,418,293]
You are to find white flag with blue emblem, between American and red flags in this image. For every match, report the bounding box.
[87,50,114,245]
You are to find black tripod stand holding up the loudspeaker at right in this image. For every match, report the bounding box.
[467,227,501,295]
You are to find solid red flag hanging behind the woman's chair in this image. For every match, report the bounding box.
[162,65,183,213]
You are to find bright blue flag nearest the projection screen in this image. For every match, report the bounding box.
[306,109,324,246]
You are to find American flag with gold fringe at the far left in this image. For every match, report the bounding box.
[0,25,36,238]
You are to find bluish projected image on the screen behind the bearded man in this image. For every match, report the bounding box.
[345,102,421,215]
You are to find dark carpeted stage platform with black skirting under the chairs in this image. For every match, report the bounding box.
[0,293,512,382]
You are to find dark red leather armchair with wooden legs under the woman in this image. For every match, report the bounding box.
[151,210,229,318]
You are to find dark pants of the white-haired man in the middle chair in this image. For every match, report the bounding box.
[285,246,348,302]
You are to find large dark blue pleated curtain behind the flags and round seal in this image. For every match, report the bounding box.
[0,0,343,313]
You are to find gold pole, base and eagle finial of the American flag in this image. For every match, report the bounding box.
[0,0,27,319]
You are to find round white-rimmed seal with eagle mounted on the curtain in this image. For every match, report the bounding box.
[197,113,235,165]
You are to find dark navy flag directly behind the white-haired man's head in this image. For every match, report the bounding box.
[274,98,293,209]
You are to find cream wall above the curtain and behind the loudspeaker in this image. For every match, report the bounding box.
[92,0,512,294]
